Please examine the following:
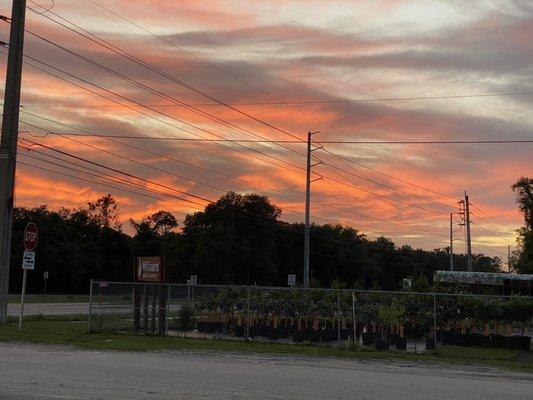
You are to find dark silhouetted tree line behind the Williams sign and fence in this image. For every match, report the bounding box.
[10,192,508,293]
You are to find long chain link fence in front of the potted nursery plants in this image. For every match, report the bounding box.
[89,282,533,352]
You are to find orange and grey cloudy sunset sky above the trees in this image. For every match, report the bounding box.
[0,0,533,259]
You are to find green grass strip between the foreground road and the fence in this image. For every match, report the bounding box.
[0,315,533,372]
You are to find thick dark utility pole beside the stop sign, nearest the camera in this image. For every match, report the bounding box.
[0,0,26,325]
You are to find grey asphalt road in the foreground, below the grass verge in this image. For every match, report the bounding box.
[0,344,533,400]
